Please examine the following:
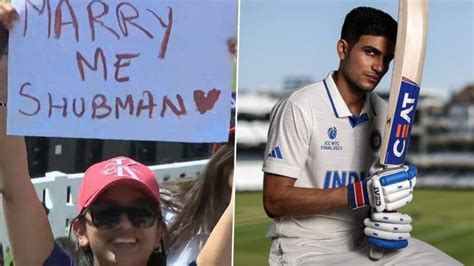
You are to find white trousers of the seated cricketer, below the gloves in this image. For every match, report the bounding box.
[269,236,462,266]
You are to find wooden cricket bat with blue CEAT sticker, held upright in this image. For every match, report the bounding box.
[370,0,428,259]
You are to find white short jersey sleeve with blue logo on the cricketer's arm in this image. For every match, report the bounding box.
[263,99,312,178]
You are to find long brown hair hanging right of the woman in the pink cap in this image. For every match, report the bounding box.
[166,143,234,254]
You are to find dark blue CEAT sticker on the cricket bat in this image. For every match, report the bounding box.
[384,77,420,165]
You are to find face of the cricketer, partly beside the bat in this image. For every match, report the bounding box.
[340,35,395,91]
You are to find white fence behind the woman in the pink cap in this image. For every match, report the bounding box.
[0,159,208,252]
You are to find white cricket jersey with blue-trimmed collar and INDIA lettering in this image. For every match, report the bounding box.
[263,72,387,239]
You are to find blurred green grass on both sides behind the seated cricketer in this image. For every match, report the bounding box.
[234,189,474,266]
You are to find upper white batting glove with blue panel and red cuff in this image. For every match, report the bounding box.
[348,165,416,212]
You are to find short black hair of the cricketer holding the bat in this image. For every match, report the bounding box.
[341,7,397,45]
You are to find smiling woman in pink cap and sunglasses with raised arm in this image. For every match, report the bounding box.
[0,18,166,265]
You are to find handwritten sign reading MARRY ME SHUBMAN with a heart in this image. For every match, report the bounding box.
[8,0,237,142]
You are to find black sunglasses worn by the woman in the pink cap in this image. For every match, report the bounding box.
[85,203,159,229]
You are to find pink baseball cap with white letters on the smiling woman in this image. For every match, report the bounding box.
[77,156,160,213]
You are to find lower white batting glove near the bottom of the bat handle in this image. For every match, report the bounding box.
[364,212,412,249]
